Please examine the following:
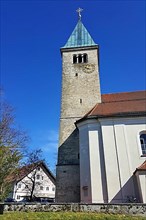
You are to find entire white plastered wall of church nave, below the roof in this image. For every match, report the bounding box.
[78,117,146,203]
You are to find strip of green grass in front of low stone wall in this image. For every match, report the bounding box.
[0,212,146,220]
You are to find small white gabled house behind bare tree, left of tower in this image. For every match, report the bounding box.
[12,162,55,201]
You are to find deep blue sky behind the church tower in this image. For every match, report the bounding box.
[1,0,146,172]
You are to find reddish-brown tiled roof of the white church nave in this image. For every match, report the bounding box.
[76,91,146,121]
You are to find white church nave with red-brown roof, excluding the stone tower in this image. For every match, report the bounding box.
[76,91,146,203]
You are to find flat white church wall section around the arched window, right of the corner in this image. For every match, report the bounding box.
[100,118,146,202]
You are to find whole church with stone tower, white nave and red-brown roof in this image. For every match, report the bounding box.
[56,8,146,203]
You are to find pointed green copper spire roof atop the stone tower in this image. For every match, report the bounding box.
[63,20,97,48]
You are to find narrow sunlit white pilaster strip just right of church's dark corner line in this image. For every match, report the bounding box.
[102,122,121,202]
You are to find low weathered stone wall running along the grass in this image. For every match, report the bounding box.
[0,203,146,217]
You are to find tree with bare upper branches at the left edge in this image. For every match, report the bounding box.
[0,94,28,200]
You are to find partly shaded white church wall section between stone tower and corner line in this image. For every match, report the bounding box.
[79,120,103,203]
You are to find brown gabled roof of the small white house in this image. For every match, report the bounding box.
[7,161,56,184]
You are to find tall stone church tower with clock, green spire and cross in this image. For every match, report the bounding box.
[56,8,101,202]
